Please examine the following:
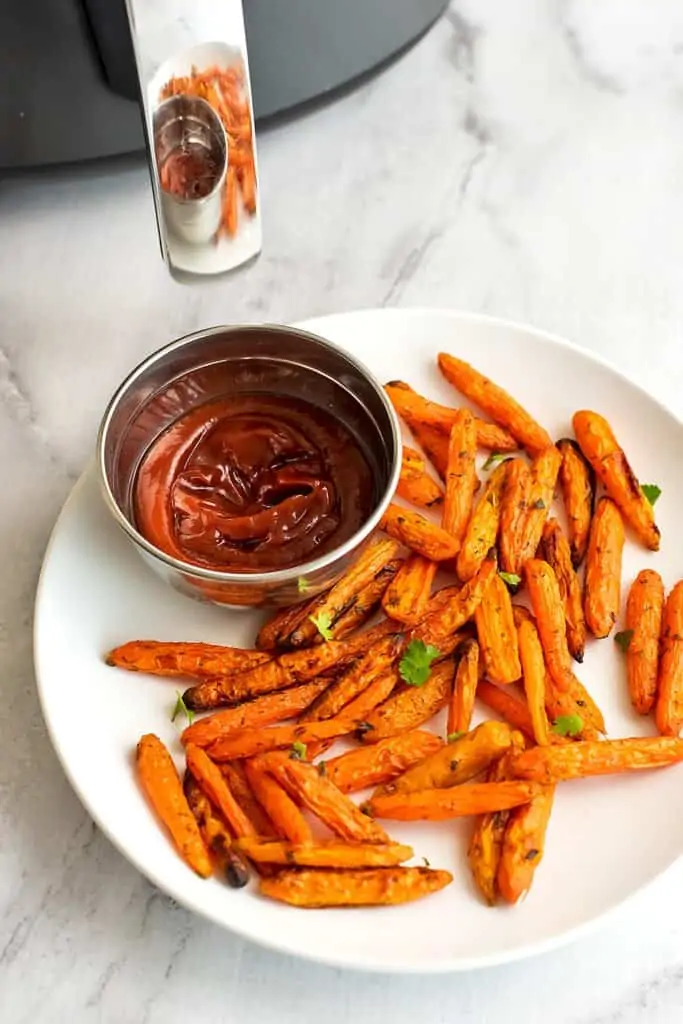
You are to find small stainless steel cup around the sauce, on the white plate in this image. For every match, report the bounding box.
[97,325,401,607]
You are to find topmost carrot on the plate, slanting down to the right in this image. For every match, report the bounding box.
[438,352,553,455]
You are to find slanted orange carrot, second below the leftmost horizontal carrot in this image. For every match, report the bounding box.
[180,676,330,746]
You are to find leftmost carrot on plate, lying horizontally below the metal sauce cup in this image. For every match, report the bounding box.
[105,640,270,679]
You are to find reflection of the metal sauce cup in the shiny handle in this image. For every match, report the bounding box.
[154,94,227,245]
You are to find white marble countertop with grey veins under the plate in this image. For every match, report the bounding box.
[0,0,683,1024]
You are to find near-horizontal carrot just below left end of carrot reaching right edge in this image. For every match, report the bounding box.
[364,778,540,821]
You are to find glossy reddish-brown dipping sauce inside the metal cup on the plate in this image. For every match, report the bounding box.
[134,394,378,572]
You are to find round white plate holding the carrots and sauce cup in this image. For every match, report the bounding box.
[35,310,683,972]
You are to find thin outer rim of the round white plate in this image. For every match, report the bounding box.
[33,306,683,976]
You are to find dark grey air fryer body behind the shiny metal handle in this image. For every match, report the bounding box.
[0,0,445,168]
